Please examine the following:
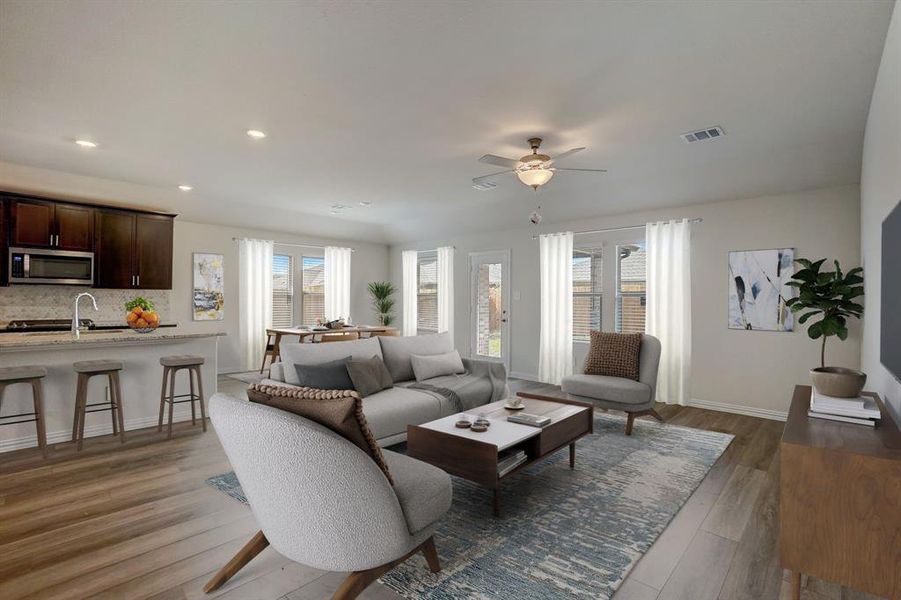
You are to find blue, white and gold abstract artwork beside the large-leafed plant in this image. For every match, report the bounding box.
[729,248,795,331]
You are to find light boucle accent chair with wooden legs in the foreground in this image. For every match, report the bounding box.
[204,394,453,599]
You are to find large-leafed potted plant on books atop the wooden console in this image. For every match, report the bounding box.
[786,258,867,398]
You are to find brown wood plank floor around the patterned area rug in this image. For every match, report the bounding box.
[0,377,884,600]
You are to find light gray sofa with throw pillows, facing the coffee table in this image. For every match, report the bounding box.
[263,333,508,446]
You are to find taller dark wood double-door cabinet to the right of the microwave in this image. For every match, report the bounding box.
[94,209,173,290]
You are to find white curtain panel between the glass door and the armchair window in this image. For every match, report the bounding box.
[538,231,573,385]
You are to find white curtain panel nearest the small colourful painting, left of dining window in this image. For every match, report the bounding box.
[238,239,273,370]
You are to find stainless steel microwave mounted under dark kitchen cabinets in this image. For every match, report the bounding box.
[9,248,94,286]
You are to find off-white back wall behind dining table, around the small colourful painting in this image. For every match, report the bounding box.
[170,219,386,373]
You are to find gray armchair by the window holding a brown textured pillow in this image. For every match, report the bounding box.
[560,334,663,435]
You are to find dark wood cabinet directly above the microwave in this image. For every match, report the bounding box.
[9,199,94,252]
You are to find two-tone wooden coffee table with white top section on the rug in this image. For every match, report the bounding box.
[407,392,594,517]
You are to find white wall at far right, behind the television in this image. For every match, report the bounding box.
[860,4,901,419]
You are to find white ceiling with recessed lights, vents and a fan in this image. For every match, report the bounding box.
[0,0,892,241]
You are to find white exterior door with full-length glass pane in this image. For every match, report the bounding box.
[469,250,510,369]
